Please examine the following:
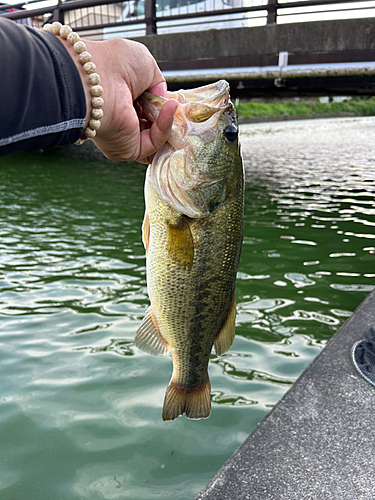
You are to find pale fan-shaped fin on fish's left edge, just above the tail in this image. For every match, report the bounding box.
[135,307,170,356]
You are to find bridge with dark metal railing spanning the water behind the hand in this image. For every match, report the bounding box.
[0,0,375,97]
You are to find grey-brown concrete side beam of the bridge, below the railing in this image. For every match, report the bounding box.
[136,19,375,70]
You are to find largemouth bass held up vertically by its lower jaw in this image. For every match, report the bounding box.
[135,80,244,420]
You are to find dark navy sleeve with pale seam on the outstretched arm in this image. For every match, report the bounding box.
[0,18,86,155]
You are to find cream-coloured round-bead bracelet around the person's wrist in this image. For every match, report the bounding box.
[43,21,104,146]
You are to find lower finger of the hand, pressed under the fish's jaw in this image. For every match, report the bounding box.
[138,99,178,158]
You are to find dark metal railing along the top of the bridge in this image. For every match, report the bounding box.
[0,0,375,39]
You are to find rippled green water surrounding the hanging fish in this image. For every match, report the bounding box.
[0,118,375,500]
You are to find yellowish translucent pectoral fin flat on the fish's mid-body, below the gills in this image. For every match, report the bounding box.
[167,215,194,271]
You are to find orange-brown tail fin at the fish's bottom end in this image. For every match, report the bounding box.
[163,377,211,420]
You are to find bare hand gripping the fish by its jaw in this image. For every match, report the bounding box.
[64,38,178,163]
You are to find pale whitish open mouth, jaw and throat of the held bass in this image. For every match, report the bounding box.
[139,80,233,218]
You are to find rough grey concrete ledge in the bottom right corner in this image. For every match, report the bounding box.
[197,291,375,500]
